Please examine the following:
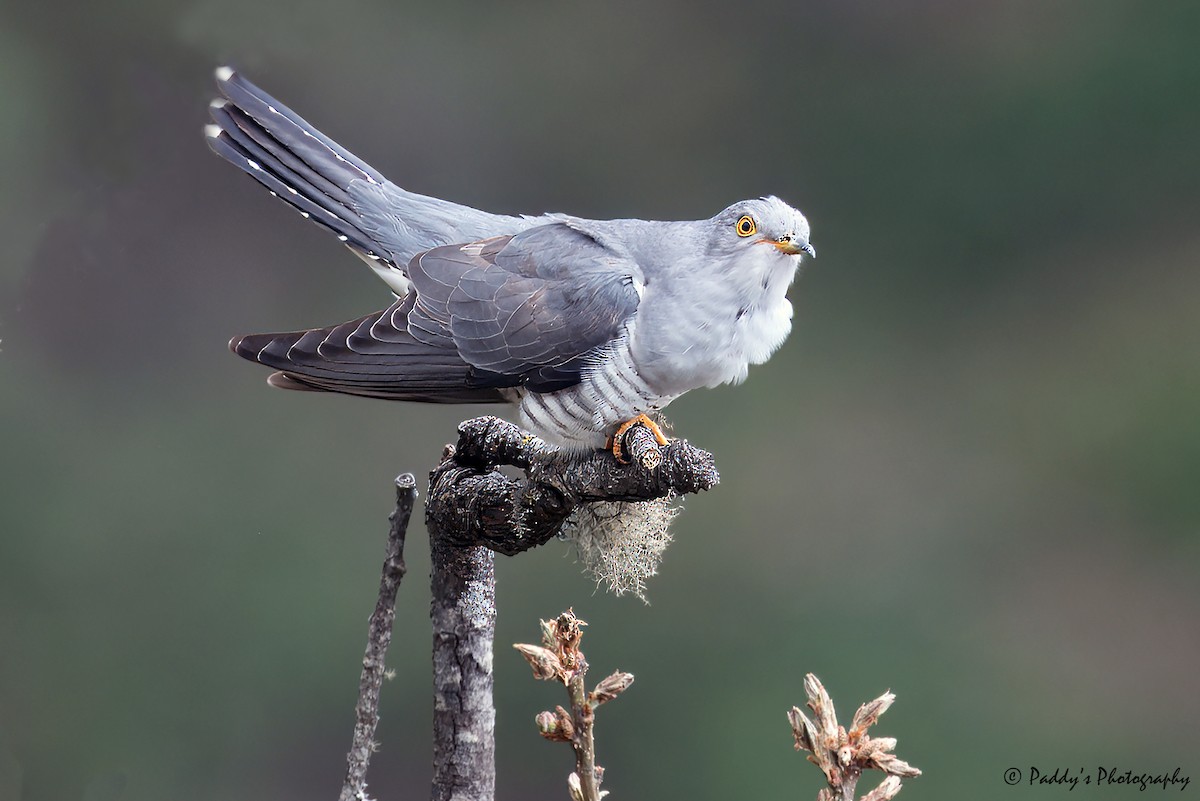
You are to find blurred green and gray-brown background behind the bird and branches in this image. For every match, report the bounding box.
[0,0,1200,801]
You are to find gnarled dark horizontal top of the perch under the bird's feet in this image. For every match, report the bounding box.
[426,417,720,555]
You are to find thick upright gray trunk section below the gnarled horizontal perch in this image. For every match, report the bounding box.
[426,507,496,801]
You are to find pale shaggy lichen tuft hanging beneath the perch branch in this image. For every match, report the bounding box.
[563,495,682,603]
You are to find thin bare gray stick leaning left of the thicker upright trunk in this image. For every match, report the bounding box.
[337,472,416,801]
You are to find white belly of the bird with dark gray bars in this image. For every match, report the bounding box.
[518,338,678,448]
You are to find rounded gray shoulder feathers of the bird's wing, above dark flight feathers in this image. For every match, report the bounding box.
[408,222,643,392]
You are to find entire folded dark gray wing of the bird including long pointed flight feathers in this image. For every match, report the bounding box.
[229,223,642,403]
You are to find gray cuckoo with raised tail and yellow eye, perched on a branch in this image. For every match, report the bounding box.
[205,67,816,458]
